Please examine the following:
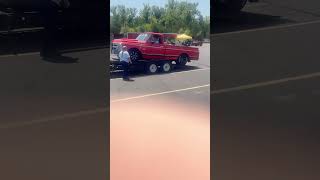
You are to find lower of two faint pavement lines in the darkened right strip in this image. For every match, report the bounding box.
[211,72,320,95]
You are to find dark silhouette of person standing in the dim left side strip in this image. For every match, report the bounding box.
[40,0,70,58]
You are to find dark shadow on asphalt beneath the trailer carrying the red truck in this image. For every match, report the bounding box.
[110,66,201,79]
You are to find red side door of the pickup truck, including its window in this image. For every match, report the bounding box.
[147,34,165,59]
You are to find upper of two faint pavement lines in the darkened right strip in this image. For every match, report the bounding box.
[211,20,320,38]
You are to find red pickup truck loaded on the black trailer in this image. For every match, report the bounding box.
[111,32,199,72]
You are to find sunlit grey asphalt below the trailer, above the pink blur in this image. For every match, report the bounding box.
[110,44,210,106]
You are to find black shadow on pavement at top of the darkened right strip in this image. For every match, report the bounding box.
[211,11,294,34]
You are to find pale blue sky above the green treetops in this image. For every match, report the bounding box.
[110,0,210,16]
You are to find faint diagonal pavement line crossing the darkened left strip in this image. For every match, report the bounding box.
[0,108,107,129]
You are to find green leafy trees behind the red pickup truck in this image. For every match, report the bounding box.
[110,0,210,40]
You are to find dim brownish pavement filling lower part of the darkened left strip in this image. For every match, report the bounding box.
[0,49,109,180]
